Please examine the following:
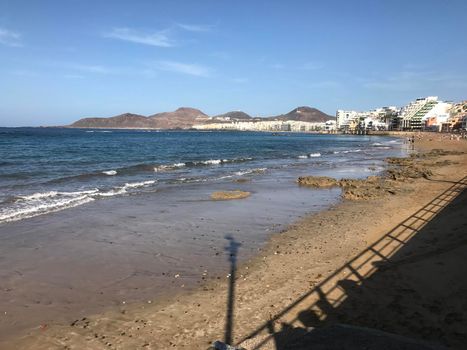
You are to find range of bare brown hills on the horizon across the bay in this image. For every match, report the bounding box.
[69,106,335,129]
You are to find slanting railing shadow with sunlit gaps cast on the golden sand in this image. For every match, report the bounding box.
[236,176,467,350]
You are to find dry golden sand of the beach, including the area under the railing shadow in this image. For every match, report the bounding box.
[0,134,467,350]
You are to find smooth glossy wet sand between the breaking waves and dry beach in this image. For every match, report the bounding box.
[0,167,339,340]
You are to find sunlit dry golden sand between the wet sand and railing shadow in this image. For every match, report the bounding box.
[0,134,465,349]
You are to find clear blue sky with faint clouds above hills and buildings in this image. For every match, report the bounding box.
[0,0,467,126]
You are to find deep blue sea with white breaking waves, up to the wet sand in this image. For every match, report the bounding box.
[0,128,406,224]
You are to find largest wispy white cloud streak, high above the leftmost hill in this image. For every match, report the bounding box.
[103,28,175,47]
